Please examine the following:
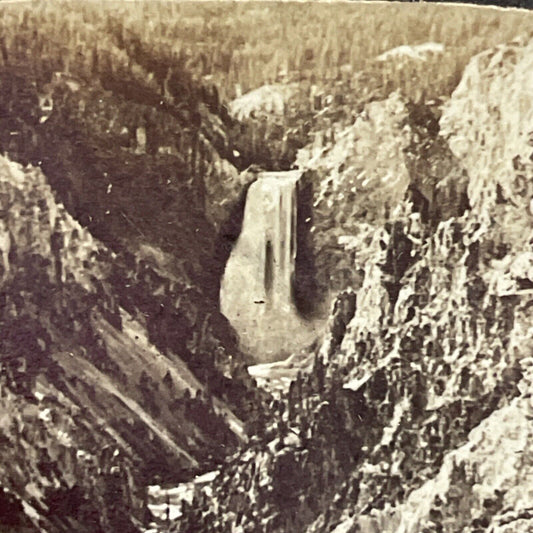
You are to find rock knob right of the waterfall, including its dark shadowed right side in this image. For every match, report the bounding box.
[297,93,468,312]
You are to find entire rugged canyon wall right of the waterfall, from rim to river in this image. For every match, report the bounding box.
[169,35,533,533]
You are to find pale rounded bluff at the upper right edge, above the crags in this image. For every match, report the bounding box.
[440,38,533,251]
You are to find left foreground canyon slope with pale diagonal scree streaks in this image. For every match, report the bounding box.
[0,158,256,531]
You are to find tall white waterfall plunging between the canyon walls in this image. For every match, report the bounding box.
[220,171,316,361]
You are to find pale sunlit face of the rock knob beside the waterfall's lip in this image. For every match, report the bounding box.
[296,90,409,227]
